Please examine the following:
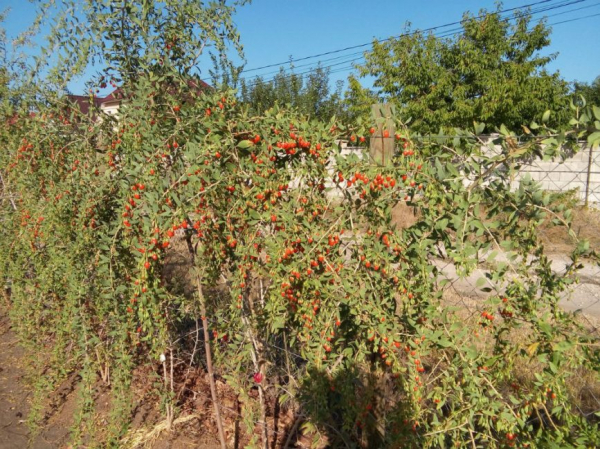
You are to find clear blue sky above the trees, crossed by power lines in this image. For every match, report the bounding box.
[0,0,600,93]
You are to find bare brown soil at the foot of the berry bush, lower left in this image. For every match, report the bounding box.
[0,307,306,449]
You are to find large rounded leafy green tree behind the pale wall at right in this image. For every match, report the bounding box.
[350,5,568,132]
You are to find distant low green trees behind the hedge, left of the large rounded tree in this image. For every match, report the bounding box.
[240,67,343,120]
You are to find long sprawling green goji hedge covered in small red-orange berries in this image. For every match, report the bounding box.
[0,2,600,447]
